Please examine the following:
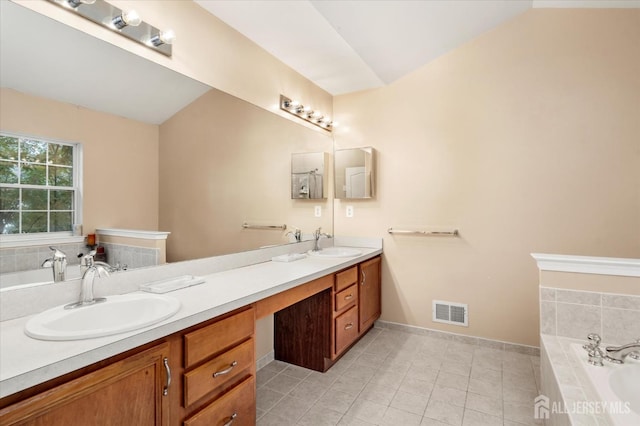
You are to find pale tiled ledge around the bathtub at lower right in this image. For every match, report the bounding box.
[537,334,640,426]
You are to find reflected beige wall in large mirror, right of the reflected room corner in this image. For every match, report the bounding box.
[160,89,333,262]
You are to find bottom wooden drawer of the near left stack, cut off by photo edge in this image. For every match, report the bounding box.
[184,376,256,426]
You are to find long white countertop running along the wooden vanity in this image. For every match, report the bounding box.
[0,248,382,398]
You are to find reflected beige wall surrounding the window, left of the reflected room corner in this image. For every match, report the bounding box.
[0,89,158,235]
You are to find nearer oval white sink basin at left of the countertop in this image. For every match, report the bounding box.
[24,293,180,340]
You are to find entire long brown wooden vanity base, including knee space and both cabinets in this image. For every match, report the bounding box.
[0,256,380,426]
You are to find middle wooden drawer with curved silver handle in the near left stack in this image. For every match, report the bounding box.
[184,339,254,407]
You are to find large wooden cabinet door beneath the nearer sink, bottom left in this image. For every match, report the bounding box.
[0,343,169,426]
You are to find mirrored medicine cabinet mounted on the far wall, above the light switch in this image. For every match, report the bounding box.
[334,146,375,199]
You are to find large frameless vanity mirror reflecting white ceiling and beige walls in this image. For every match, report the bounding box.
[0,1,333,286]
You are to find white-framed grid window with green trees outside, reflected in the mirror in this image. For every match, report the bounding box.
[0,133,81,235]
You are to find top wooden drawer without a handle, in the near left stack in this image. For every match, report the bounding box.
[184,308,254,368]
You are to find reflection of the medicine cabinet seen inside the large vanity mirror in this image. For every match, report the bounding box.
[291,152,329,199]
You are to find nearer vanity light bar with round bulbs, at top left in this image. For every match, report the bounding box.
[48,0,176,56]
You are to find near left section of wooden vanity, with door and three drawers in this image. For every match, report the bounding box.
[0,307,256,426]
